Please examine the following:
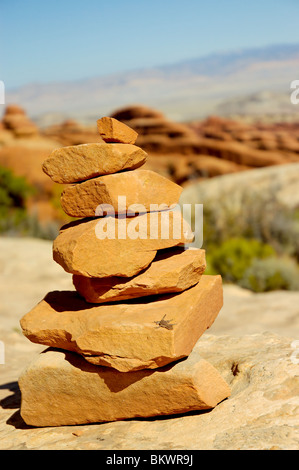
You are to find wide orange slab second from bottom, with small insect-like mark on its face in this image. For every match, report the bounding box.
[21,275,223,372]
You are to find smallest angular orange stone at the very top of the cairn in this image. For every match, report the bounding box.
[97,117,138,144]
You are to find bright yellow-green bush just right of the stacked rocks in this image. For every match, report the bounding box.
[206,238,275,282]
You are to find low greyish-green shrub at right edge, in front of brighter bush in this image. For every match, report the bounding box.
[239,257,299,292]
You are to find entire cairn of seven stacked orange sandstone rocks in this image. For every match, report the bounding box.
[19,117,230,427]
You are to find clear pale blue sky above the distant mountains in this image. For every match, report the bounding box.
[0,0,299,88]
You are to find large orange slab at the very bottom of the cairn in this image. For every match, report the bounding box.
[19,349,230,427]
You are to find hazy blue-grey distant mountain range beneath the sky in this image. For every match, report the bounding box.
[6,44,299,126]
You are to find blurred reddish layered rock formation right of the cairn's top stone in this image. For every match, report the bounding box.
[112,106,299,185]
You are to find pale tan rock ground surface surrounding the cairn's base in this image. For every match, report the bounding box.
[0,237,299,453]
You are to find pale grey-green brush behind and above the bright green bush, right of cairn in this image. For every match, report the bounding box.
[203,191,299,260]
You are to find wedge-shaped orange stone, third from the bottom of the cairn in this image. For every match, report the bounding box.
[73,248,206,303]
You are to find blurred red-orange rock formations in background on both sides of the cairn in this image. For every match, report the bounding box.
[0,105,299,233]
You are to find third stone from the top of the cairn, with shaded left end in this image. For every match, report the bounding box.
[61,170,182,217]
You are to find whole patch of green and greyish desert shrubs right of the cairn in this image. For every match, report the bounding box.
[204,192,299,292]
